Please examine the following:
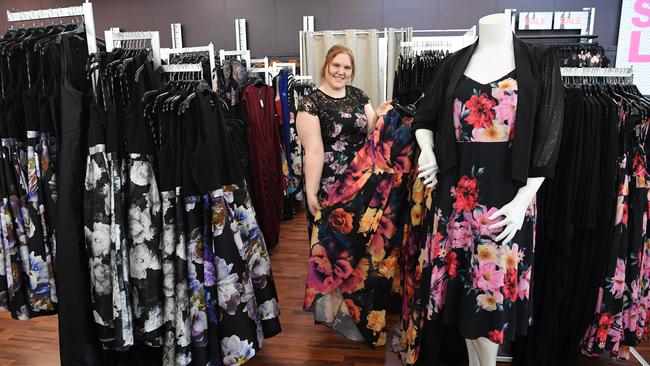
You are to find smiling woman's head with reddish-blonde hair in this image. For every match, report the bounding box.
[320,45,354,90]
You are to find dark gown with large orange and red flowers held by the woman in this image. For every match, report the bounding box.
[304,110,413,346]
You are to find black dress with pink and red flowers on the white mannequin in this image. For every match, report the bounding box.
[425,73,536,344]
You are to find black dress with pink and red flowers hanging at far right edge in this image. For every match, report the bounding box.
[581,95,650,358]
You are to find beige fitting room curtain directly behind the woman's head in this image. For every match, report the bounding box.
[302,29,382,108]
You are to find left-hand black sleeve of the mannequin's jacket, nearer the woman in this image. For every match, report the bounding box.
[411,58,449,132]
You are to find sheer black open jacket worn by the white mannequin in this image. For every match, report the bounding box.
[413,37,564,184]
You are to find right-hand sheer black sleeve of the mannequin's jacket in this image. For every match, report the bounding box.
[528,48,564,178]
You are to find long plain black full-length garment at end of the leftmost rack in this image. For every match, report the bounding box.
[55,30,101,366]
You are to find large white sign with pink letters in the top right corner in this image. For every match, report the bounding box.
[616,0,650,95]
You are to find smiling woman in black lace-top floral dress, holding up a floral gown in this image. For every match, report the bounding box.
[296,45,413,346]
